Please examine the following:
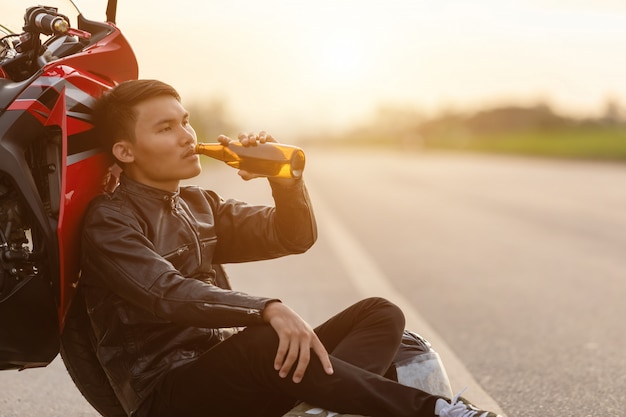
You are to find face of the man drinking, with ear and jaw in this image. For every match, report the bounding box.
[117,96,202,191]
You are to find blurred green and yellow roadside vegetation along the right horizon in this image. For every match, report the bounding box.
[307,102,626,161]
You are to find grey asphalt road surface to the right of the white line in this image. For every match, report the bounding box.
[314,150,626,417]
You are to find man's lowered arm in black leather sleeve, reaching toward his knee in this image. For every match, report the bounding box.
[82,202,275,328]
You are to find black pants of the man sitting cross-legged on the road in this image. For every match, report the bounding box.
[143,298,437,417]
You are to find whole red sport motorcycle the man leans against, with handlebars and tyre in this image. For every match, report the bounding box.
[0,0,138,417]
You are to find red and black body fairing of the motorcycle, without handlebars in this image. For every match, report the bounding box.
[0,22,137,369]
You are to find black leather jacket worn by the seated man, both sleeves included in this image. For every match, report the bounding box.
[81,175,317,415]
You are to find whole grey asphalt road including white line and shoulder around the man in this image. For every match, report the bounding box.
[0,151,626,417]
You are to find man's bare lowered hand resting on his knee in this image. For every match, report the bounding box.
[263,302,333,384]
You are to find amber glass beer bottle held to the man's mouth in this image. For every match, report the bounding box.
[196,141,305,178]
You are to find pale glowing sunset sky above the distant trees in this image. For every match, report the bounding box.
[57,0,626,133]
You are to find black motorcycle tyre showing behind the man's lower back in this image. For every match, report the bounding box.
[61,287,127,417]
